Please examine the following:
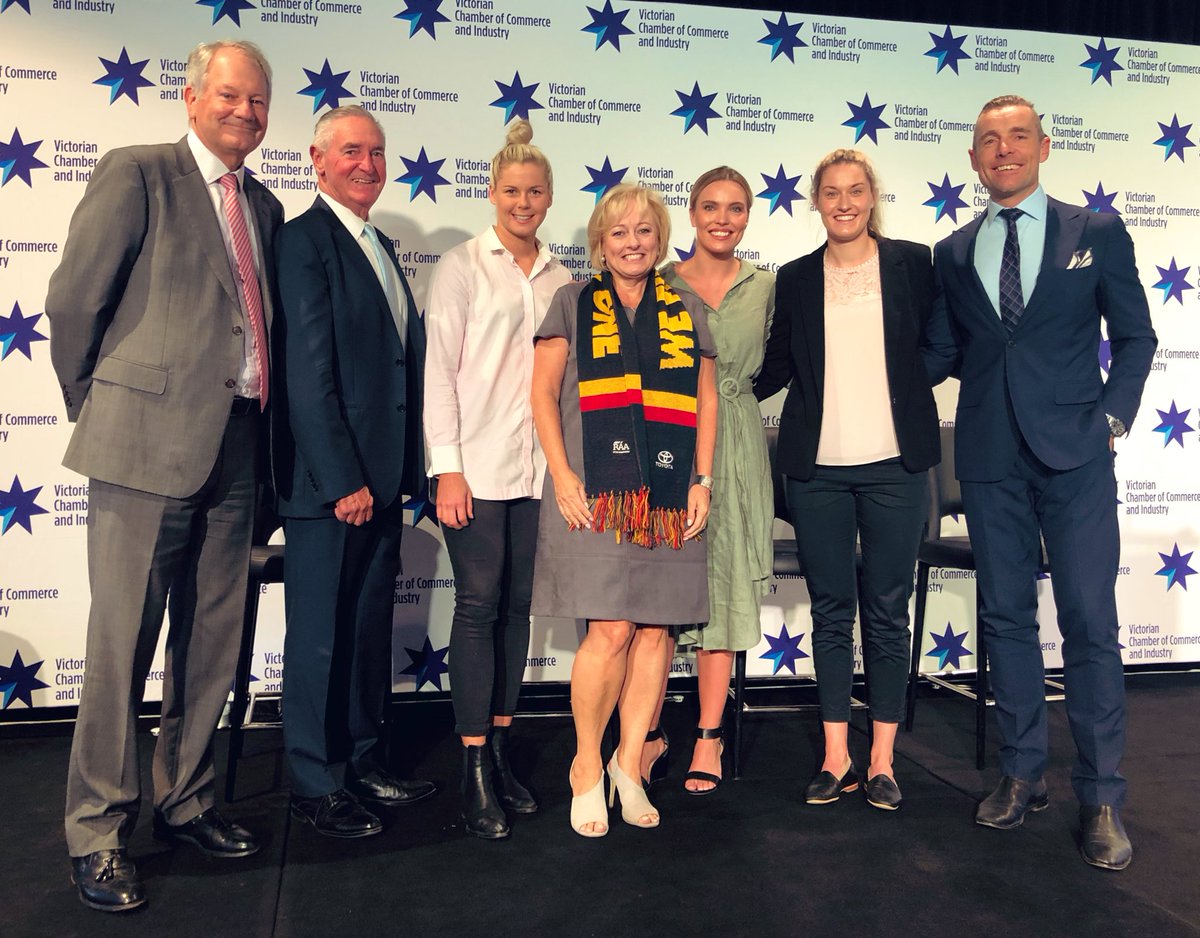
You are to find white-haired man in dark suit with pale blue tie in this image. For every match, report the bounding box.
[274,107,434,837]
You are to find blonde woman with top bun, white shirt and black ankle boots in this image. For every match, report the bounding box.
[425,120,571,840]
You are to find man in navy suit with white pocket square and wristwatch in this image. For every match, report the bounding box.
[926,95,1157,870]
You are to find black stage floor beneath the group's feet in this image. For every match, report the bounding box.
[0,674,1200,938]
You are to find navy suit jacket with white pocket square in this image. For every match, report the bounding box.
[926,199,1158,482]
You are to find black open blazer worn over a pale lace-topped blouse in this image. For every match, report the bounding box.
[754,239,942,481]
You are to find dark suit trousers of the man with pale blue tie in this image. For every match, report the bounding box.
[283,498,403,798]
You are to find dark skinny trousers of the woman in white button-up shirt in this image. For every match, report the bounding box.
[442,498,541,736]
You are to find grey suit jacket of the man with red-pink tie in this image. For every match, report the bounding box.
[46,138,283,498]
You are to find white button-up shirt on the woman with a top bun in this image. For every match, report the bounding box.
[425,227,571,500]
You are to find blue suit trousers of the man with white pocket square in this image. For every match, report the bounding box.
[961,444,1126,807]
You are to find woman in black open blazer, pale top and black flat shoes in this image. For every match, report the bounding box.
[754,150,941,811]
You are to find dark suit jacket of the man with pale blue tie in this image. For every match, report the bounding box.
[272,197,425,518]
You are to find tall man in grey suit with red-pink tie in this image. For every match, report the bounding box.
[46,42,283,912]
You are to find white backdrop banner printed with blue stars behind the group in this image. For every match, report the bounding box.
[0,0,1200,709]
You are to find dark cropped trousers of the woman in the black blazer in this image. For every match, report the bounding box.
[787,459,929,723]
